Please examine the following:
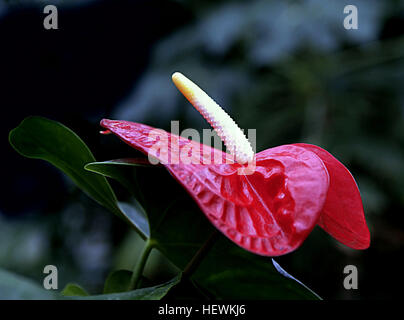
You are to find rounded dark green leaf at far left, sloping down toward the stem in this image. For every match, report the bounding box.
[9,117,144,235]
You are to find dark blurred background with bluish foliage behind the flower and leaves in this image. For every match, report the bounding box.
[0,0,404,299]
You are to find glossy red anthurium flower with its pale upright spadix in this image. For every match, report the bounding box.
[101,73,370,256]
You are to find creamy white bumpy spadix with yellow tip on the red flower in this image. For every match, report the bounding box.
[172,72,254,164]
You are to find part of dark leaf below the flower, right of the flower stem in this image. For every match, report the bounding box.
[192,236,319,300]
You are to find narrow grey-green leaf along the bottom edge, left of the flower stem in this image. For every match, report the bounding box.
[73,274,181,300]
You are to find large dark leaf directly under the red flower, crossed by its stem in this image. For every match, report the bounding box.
[86,159,318,299]
